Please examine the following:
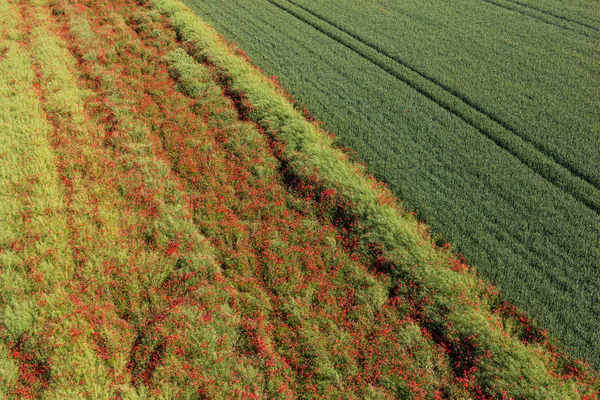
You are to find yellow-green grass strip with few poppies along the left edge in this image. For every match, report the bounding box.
[0,2,83,396]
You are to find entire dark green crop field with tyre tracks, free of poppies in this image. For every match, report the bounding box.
[185,0,600,365]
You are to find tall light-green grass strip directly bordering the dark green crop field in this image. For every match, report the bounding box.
[150,0,596,398]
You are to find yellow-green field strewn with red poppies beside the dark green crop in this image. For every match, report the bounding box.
[0,0,600,399]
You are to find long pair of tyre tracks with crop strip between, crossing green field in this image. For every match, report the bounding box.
[267,0,600,214]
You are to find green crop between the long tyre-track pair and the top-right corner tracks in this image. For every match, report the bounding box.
[279,0,600,187]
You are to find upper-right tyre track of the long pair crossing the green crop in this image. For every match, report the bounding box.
[278,0,600,190]
